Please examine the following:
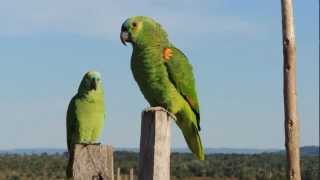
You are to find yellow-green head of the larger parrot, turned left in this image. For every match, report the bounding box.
[120,16,167,46]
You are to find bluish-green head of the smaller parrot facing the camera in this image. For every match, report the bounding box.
[78,71,103,93]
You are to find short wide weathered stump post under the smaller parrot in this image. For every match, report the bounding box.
[71,144,114,180]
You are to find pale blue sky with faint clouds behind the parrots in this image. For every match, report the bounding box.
[0,0,319,149]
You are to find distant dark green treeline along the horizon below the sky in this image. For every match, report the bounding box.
[0,151,319,180]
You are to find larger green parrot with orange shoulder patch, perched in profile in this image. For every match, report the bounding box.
[120,16,205,160]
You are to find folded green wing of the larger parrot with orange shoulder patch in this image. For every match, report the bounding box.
[165,46,200,130]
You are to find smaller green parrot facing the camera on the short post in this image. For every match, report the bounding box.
[66,71,106,178]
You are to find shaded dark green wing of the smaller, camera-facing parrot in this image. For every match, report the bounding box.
[67,96,77,152]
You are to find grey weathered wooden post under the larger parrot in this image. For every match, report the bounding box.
[139,107,172,180]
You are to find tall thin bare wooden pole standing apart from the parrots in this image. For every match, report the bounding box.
[281,0,301,180]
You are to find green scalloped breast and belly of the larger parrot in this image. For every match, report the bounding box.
[131,48,179,111]
